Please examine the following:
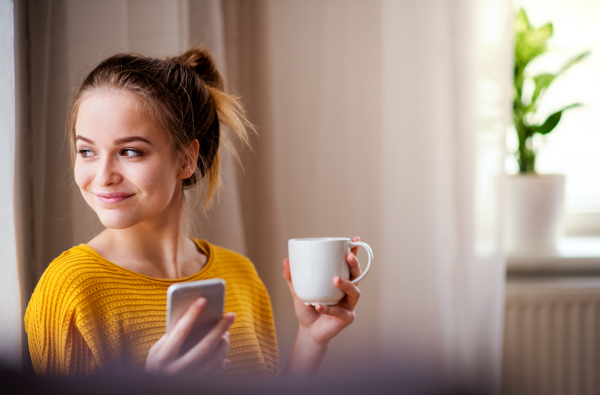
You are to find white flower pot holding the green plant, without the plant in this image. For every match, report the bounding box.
[506,174,565,255]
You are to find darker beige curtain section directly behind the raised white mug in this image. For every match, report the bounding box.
[225,1,384,380]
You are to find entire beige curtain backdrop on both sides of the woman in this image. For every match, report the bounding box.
[16,0,510,388]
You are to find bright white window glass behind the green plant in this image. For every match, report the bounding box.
[506,0,600,235]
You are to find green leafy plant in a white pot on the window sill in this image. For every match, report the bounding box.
[507,9,589,253]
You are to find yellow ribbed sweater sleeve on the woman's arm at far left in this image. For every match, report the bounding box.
[25,256,98,376]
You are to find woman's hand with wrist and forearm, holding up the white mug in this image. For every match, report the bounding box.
[283,237,361,376]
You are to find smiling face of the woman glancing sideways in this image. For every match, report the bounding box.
[75,90,182,229]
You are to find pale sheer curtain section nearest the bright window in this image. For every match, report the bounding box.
[381,1,512,388]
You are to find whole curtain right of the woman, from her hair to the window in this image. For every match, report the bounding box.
[225,0,511,391]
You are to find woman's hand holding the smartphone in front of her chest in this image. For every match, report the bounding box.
[145,298,235,375]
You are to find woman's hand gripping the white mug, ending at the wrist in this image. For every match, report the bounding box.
[283,237,361,346]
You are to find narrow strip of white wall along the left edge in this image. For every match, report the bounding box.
[0,0,22,368]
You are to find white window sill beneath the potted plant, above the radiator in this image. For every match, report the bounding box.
[507,236,600,278]
